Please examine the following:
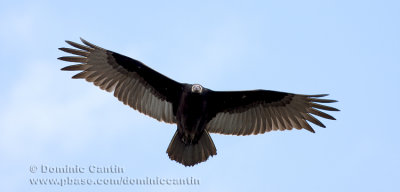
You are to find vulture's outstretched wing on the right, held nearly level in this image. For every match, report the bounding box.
[207,90,338,135]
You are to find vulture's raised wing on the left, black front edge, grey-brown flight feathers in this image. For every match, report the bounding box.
[58,38,182,123]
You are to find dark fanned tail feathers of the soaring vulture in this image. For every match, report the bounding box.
[167,130,217,166]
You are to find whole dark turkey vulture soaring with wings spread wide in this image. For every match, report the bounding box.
[58,38,339,166]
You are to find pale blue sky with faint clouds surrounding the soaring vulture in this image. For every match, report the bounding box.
[0,0,400,191]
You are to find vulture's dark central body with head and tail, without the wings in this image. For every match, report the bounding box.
[167,84,217,165]
